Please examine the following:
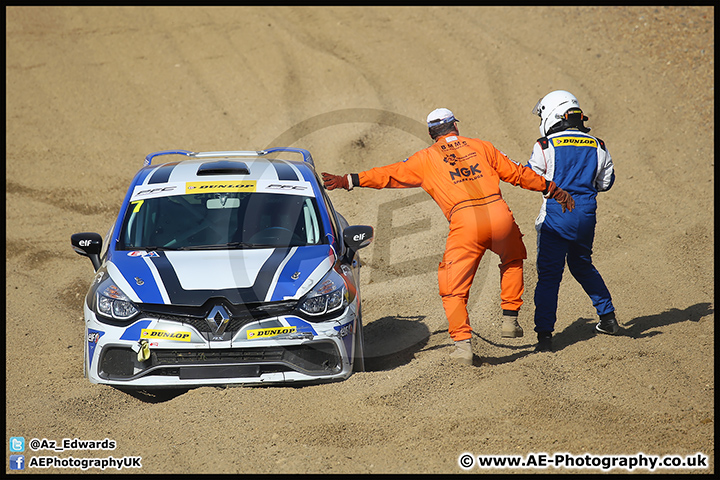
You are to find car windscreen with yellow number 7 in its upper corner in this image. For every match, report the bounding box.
[117,192,327,250]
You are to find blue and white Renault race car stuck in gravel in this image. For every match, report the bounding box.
[71,148,373,389]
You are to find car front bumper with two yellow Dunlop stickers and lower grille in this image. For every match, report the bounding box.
[85,305,357,388]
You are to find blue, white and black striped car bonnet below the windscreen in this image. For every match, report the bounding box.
[107,245,336,306]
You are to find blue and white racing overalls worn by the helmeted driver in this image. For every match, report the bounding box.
[527,128,615,333]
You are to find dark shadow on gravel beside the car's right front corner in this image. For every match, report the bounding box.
[363,316,430,372]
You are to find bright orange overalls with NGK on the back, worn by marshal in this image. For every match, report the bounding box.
[353,134,546,342]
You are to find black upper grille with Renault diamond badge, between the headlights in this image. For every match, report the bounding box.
[138,300,297,334]
